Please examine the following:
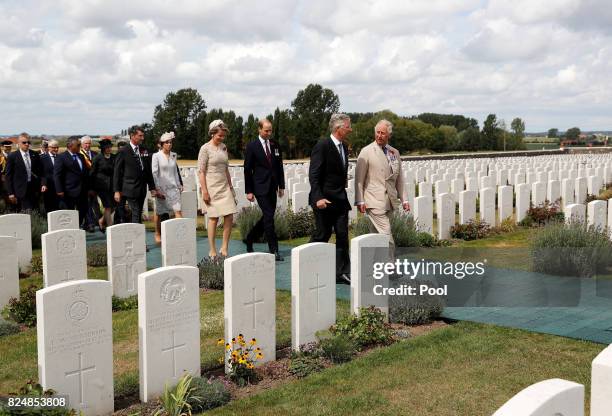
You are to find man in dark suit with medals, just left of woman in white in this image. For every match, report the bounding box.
[113,126,155,223]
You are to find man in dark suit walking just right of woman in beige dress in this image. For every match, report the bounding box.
[244,119,285,261]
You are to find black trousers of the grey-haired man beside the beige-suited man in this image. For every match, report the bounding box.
[310,205,351,276]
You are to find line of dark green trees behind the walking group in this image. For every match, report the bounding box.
[131,84,525,159]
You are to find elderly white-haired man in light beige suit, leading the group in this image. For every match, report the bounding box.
[355,120,410,252]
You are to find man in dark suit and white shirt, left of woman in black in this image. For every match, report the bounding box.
[53,137,90,223]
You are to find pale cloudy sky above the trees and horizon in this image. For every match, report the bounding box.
[0,0,612,134]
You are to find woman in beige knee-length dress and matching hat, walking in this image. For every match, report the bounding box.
[198,120,238,257]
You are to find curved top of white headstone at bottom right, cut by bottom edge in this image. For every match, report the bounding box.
[493,378,584,416]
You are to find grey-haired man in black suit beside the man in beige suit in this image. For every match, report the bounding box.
[308,114,352,283]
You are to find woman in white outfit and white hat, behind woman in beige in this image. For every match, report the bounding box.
[151,132,183,243]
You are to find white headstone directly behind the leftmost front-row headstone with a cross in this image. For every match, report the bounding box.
[41,230,87,287]
